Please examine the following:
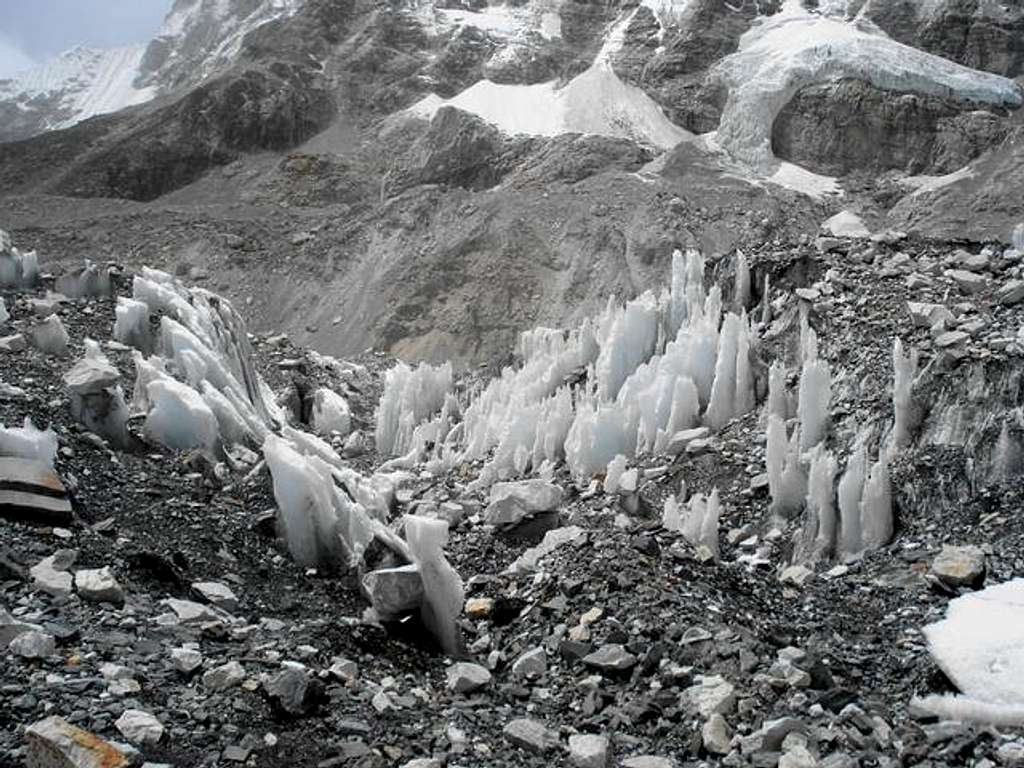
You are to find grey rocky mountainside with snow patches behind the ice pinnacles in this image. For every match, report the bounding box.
[0,0,1024,362]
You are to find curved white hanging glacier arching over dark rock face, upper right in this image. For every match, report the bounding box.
[712,9,1022,171]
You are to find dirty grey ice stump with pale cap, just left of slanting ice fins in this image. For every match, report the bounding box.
[63,339,128,447]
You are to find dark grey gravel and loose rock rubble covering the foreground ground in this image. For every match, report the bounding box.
[0,231,1024,767]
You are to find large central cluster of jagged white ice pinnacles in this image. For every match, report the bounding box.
[448,251,756,487]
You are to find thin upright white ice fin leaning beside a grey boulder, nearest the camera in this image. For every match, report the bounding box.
[406,515,466,656]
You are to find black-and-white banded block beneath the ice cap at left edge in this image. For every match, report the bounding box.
[0,457,73,525]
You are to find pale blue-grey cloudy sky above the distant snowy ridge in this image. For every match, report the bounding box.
[0,0,173,77]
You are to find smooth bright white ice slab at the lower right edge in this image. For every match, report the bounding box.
[923,579,1024,723]
